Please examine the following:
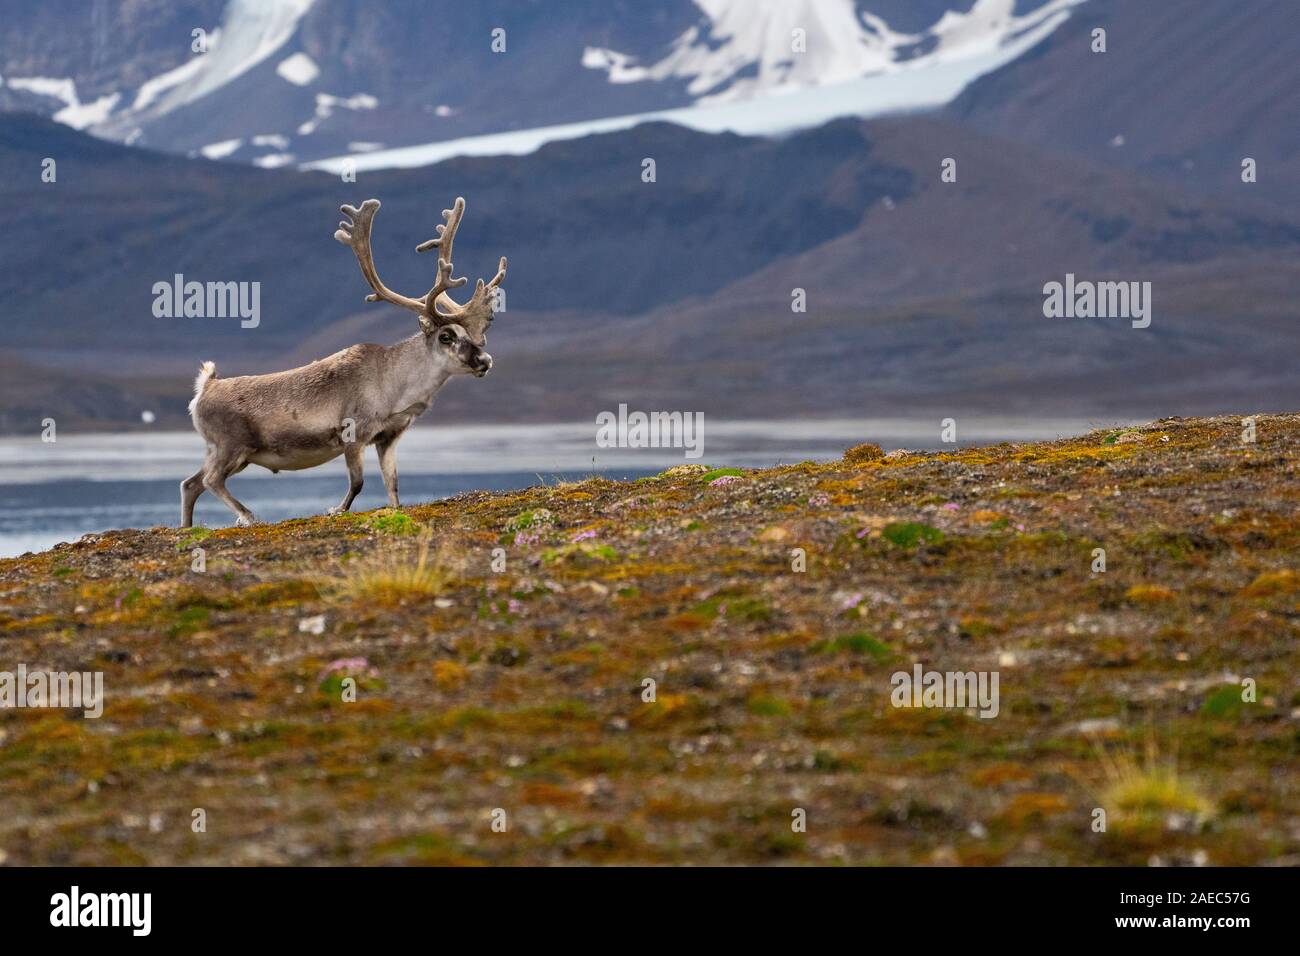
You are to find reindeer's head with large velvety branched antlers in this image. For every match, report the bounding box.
[334,196,506,350]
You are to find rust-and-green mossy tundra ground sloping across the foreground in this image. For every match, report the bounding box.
[0,415,1300,865]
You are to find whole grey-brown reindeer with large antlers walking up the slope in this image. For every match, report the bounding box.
[181,198,506,528]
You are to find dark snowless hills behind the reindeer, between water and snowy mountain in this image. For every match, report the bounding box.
[0,105,1300,425]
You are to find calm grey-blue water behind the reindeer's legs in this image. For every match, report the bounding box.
[0,419,1112,557]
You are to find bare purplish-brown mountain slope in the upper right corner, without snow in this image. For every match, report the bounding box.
[948,0,1300,195]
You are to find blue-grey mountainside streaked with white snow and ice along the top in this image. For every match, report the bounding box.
[0,0,1084,168]
